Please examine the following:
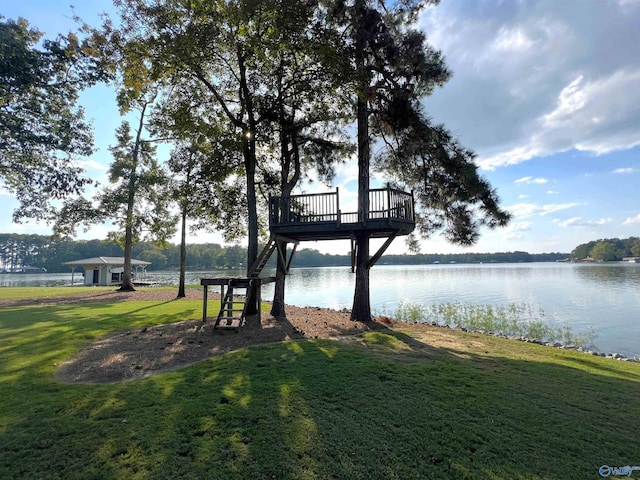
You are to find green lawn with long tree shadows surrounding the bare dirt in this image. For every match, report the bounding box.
[0,289,640,480]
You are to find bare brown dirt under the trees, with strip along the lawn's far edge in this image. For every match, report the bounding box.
[2,289,392,383]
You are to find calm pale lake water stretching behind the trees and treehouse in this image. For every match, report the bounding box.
[0,263,640,357]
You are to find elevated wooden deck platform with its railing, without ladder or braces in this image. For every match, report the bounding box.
[269,187,415,241]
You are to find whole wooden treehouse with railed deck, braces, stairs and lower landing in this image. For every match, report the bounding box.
[200,186,415,329]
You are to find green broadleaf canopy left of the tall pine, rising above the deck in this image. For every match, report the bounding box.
[96,0,360,310]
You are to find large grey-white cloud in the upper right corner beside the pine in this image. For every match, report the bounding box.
[420,0,640,170]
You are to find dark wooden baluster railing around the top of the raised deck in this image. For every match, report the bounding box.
[269,187,415,225]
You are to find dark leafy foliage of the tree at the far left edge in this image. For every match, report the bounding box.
[0,16,109,222]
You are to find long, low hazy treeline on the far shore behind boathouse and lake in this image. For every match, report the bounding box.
[0,233,569,273]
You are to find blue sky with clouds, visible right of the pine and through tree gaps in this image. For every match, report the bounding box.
[0,0,640,254]
